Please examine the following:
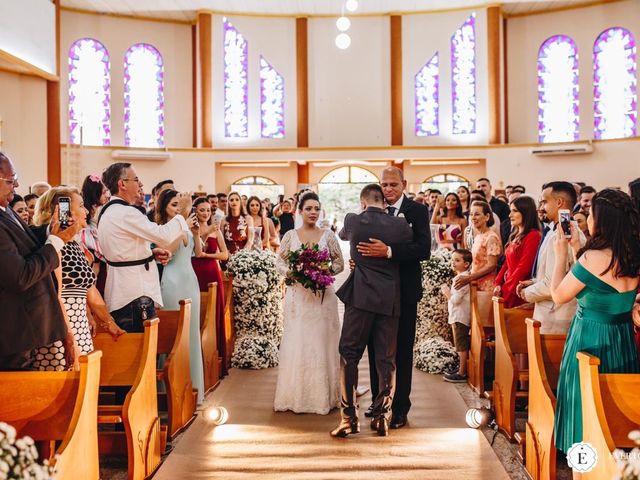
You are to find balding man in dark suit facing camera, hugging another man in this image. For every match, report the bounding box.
[356,167,431,428]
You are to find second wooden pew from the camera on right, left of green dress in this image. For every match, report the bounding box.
[526,318,567,480]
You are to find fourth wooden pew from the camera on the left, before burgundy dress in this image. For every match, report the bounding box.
[200,282,220,394]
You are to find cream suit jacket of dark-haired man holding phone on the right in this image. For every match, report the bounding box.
[524,226,586,334]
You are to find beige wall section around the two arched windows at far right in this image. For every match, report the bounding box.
[507,0,640,143]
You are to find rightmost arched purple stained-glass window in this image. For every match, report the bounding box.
[593,27,637,139]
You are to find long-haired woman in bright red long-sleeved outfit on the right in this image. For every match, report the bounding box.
[493,197,542,308]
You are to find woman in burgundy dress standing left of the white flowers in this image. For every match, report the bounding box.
[191,197,229,374]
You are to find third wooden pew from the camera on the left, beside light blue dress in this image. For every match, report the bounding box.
[156,298,196,440]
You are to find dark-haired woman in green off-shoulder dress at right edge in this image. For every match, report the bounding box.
[551,189,640,478]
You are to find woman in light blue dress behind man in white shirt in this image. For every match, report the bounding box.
[156,190,204,404]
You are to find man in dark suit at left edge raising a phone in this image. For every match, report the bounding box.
[0,153,77,371]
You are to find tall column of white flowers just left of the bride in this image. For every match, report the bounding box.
[227,250,282,369]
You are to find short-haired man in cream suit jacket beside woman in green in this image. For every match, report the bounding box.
[517,182,586,334]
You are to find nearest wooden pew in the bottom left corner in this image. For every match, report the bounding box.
[0,352,102,480]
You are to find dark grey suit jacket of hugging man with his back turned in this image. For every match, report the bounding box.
[336,207,412,316]
